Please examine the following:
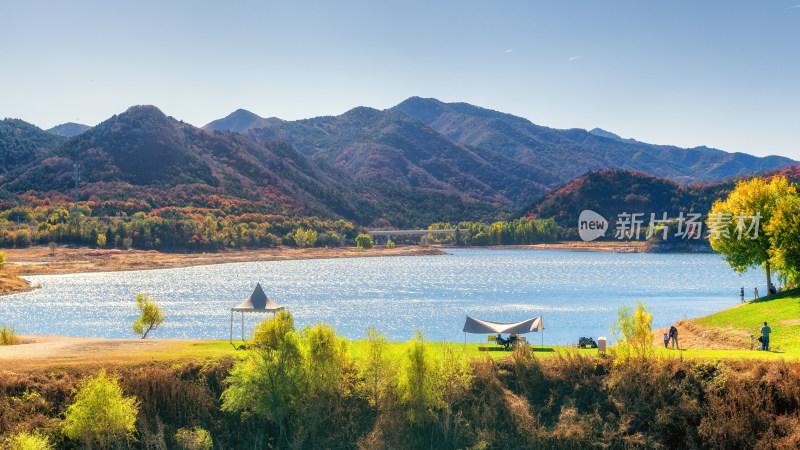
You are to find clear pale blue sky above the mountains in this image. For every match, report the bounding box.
[0,0,800,159]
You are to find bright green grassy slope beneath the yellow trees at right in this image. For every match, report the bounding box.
[694,289,800,351]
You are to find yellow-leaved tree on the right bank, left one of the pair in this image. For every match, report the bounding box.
[706,176,796,287]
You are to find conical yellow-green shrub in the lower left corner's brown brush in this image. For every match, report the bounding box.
[63,370,139,448]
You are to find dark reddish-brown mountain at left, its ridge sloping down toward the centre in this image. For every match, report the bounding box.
[0,106,497,227]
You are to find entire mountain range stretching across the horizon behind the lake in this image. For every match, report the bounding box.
[0,97,795,227]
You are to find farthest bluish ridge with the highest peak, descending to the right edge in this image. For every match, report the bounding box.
[395,97,796,183]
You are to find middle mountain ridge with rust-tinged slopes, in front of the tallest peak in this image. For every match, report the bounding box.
[248,107,558,205]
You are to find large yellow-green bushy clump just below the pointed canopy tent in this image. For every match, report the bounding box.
[222,310,354,448]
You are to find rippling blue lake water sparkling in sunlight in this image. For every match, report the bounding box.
[0,250,766,345]
